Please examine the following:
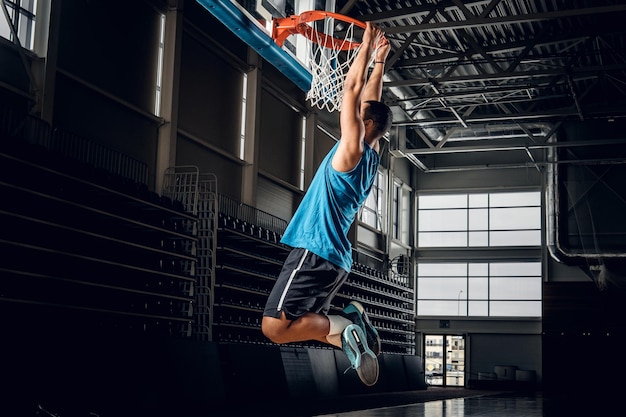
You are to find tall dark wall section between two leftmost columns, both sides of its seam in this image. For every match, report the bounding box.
[48,0,160,186]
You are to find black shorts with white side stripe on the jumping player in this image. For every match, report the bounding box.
[263,248,348,320]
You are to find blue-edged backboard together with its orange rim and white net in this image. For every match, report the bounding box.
[197,0,365,112]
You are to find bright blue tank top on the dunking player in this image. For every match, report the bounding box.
[281,143,380,272]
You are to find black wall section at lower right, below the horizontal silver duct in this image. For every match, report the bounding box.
[543,282,626,394]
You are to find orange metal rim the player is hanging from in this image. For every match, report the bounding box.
[272,10,366,51]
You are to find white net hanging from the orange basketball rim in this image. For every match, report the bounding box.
[307,17,359,112]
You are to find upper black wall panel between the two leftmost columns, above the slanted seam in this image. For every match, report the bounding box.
[57,0,160,111]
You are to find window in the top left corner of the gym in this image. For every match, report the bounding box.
[0,0,37,50]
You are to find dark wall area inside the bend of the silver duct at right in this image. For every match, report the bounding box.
[554,120,626,262]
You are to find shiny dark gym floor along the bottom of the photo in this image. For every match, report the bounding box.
[213,387,615,417]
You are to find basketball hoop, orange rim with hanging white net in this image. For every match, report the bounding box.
[272,10,366,112]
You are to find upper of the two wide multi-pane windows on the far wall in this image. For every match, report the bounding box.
[418,192,541,247]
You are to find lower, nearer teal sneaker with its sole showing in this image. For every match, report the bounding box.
[341,324,379,387]
